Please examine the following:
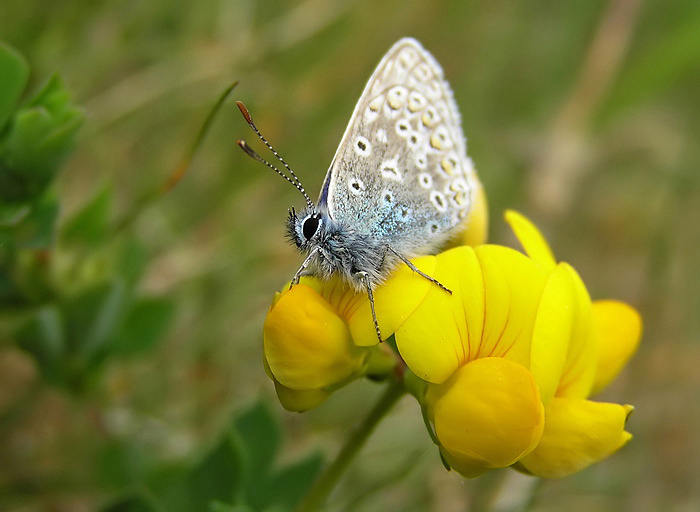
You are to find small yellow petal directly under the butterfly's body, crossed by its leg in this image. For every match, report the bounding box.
[342,256,436,346]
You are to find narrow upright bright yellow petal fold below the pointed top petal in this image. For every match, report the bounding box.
[530,265,576,405]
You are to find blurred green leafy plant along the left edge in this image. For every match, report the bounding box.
[0,44,175,392]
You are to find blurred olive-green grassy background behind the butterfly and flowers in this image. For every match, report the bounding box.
[0,0,700,512]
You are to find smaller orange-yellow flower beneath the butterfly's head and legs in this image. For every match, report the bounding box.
[263,256,435,411]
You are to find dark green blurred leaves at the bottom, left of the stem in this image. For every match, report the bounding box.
[102,402,321,512]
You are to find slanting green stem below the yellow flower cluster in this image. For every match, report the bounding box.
[296,379,405,512]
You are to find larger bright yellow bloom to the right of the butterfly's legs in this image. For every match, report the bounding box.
[396,212,641,477]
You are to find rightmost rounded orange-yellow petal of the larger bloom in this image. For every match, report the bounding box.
[592,300,642,393]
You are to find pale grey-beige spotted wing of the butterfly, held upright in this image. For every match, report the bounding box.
[319,38,480,256]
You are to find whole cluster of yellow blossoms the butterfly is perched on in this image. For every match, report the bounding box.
[264,206,641,477]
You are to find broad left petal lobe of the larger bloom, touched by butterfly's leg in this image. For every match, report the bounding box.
[396,247,484,383]
